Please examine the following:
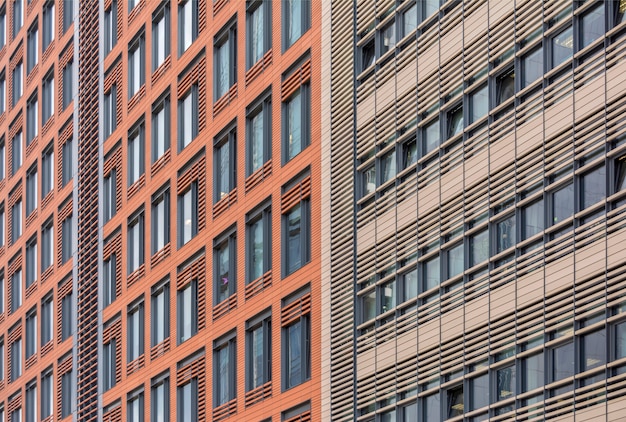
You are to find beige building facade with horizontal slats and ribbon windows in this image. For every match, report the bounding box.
[322,0,626,422]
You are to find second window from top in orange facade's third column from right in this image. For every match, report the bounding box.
[213,126,237,203]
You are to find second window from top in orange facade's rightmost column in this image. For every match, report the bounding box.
[283,84,311,163]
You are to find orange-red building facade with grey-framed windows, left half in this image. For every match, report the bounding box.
[0,0,322,422]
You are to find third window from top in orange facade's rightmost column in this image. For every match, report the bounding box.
[282,200,311,276]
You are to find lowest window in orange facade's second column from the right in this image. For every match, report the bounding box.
[246,309,272,391]
